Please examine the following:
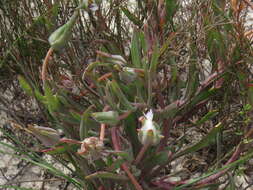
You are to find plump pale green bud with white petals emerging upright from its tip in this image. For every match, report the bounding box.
[138,110,163,145]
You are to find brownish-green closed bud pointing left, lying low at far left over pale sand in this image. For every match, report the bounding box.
[28,125,60,147]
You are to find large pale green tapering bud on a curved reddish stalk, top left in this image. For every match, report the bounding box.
[48,11,79,50]
